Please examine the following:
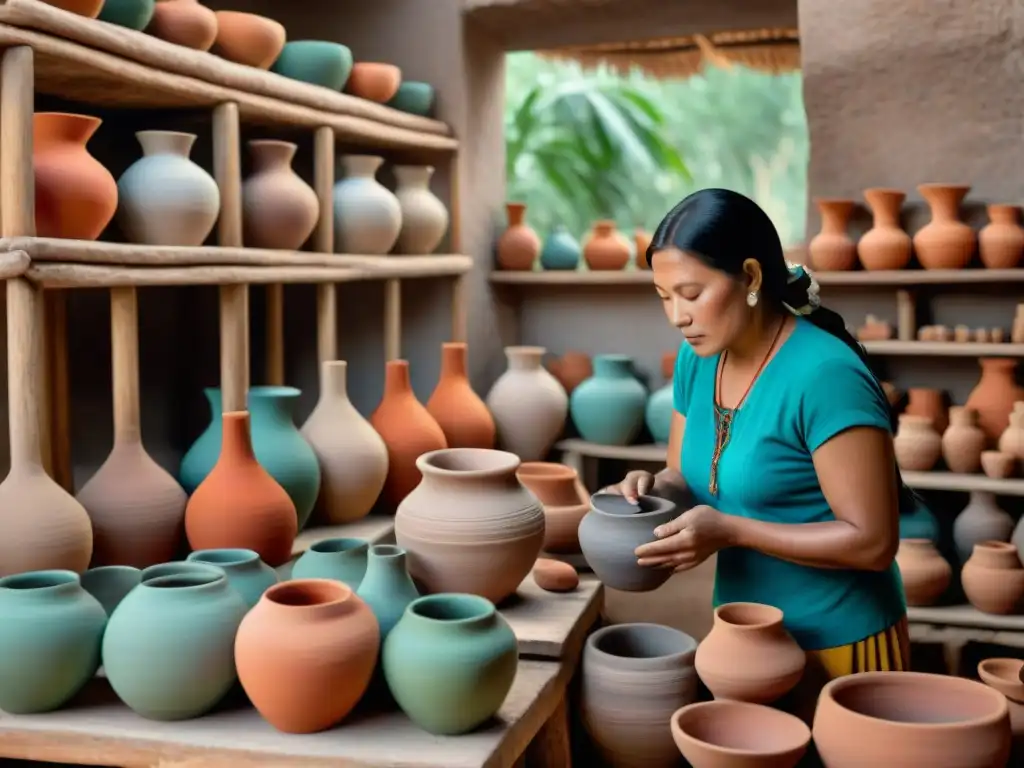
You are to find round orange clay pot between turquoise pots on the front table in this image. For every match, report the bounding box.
[234,579,380,733]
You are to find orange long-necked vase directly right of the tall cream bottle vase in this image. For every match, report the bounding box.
[370,360,447,509]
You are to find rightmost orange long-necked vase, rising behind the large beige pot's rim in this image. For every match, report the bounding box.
[427,341,497,449]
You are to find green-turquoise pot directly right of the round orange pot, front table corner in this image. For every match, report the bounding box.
[383,594,519,736]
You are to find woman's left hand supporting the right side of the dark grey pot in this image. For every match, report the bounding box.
[634,505,732,572]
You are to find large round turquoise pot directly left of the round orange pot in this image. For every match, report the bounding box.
[102,563,248,720]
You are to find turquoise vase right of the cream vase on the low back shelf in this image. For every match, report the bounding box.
[569,354,647,445]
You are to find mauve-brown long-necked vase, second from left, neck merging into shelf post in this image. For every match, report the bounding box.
[78,288,188,568]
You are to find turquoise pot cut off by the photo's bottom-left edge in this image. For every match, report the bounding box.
[0,570,106,715]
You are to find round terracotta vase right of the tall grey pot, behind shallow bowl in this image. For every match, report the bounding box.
[693,603,807,705]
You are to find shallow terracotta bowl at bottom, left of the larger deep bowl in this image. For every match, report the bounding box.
[671,700,811,768]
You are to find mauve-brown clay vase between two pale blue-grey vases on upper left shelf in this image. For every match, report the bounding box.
[242,139,319,251]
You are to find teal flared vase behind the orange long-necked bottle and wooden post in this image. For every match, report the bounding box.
[178,387,321,530]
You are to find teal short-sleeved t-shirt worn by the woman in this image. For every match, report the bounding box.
[674,317,906,650]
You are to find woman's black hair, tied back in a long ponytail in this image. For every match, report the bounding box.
[645,188,920,514]
